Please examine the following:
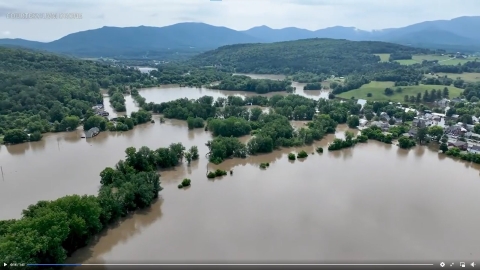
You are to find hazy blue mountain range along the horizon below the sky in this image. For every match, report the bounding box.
[0,16,480,59]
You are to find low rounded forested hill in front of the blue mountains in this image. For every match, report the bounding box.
[190,38,428,76]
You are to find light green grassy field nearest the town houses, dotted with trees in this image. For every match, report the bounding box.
[338,81,463,103]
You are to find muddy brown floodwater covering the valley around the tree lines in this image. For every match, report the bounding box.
[0,74,480,263]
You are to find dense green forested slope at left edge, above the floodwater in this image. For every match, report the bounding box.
[0,47,156,141]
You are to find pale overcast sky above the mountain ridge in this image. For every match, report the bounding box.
[0,0,480,41]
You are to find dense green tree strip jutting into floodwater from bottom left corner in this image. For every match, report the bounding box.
[0,143,198,269]
